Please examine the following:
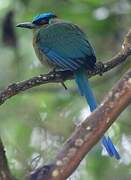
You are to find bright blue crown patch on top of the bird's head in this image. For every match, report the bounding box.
[32,13,57,24]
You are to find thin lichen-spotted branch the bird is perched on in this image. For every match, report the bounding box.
[0,29,131,104]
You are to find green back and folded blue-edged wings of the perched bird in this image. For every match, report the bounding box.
[36,23,96,71]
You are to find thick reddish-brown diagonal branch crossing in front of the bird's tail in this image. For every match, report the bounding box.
[26,67,131,180]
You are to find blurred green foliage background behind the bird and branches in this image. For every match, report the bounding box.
[0,0,131,180]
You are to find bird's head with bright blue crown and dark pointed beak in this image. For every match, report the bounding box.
[16,13,57,29]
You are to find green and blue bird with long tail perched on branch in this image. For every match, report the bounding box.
[17,12,120,160]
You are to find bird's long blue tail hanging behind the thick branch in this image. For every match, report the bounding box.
[75,71,120,160]
